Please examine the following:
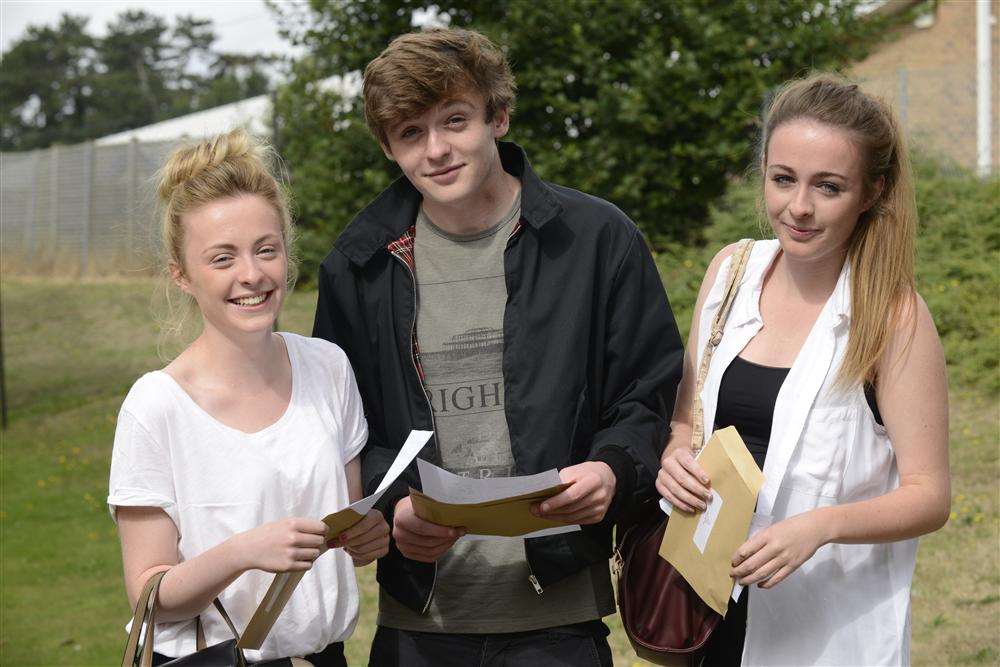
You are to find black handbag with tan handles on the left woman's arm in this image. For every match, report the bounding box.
[122,571,310,667]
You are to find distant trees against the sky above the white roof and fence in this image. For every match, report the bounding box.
[0,10,276,150]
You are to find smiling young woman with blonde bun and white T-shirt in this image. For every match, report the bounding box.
[108,130,389,665]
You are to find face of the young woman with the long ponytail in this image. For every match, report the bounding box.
[764,120,872,260]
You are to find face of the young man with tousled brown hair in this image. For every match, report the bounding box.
[383,93,509,215]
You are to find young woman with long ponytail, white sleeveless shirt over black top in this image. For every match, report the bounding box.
[657,74,950,665]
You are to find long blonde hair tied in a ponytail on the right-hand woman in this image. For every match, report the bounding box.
[760,73,917,386]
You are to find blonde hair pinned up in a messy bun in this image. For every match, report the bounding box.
[156,129,297,347]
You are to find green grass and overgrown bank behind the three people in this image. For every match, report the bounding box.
[0,160,1000,665]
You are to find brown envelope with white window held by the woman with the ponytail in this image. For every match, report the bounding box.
[660,426,764,616]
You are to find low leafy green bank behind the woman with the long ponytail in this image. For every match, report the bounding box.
[657,154,1000,396]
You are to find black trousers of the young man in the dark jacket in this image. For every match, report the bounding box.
[368,621,613,667]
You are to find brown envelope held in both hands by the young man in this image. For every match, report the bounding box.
[410,484,569,537]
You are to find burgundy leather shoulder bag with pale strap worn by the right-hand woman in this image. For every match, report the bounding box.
[613,240,753,667]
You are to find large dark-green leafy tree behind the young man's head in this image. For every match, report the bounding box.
[274,0,908,280]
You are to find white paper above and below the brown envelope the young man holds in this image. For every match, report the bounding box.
[417,459,580,540]
